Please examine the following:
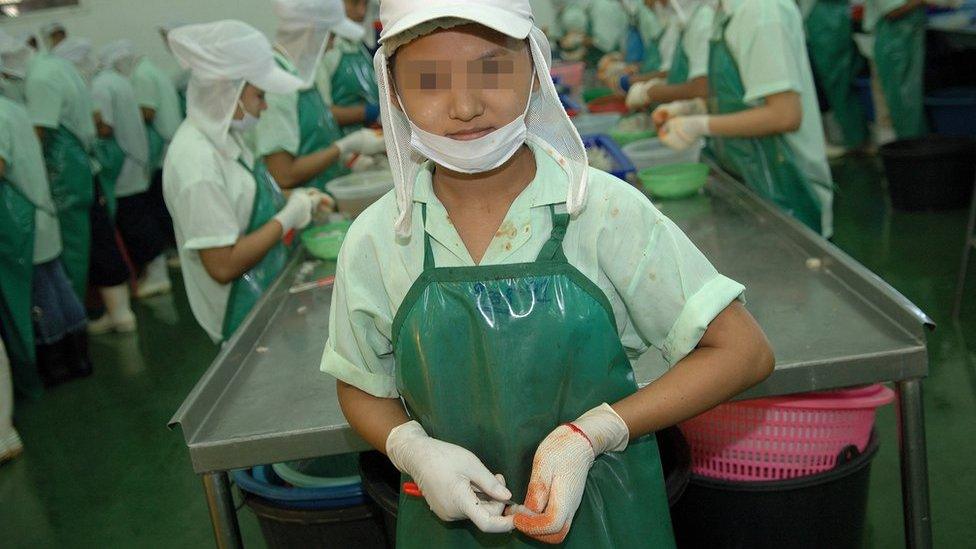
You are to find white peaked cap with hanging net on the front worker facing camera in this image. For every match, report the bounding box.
[373,0,588,238]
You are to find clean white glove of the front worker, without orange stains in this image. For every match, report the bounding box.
[386,421,514,533]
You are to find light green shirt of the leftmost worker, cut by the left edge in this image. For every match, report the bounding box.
[0,97,61,265]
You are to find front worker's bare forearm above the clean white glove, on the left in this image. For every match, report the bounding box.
[336,381,410,454]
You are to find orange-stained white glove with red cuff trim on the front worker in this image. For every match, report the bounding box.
[515,403,630,543]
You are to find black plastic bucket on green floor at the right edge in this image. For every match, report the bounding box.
[881,135,976,211]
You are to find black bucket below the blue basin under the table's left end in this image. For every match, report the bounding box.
[244,492,386,549]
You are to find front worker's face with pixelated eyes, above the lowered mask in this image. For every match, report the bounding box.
[391,24,537,141]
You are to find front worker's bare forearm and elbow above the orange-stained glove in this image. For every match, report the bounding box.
[613,304,774,438]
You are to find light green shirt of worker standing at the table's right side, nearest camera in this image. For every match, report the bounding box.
[724,0,833,234]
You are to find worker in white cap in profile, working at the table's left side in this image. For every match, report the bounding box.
[163,21,330,341]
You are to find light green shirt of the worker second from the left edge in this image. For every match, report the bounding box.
[25,53,95,150]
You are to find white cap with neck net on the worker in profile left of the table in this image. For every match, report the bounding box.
[168,20,302,155]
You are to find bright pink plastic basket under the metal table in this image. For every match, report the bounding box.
[681,385,895,481]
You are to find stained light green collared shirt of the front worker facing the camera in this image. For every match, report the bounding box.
[322,138,744,398]
